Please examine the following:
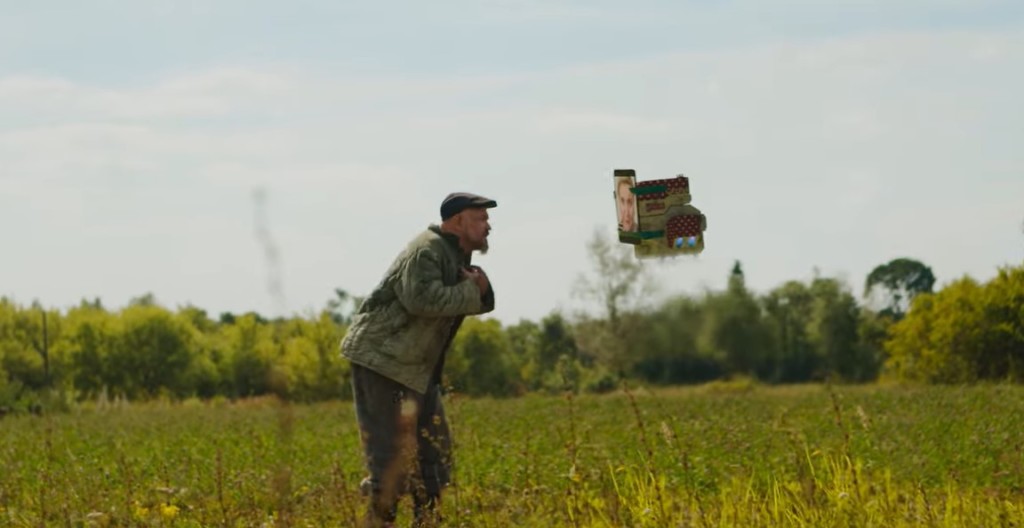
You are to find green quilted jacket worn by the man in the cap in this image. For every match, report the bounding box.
[340,225,495,393]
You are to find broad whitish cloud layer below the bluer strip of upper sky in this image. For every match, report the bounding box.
[0,27,1024,319]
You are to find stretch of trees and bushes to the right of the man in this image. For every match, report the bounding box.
[449,234,1024,396]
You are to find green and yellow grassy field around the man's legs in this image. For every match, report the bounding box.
[0,384,1024,527]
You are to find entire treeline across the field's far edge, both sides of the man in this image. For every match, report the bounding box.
[0,232,1024,413]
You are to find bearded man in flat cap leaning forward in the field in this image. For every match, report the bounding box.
[341,192,498,527]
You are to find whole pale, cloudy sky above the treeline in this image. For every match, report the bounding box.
[0,0,1024,323]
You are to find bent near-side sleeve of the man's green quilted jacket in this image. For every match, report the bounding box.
[395,249,483,317]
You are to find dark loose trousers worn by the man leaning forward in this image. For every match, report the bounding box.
[352,364,452,521]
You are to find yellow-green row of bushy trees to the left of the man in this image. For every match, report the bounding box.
[0,295,347,410]
